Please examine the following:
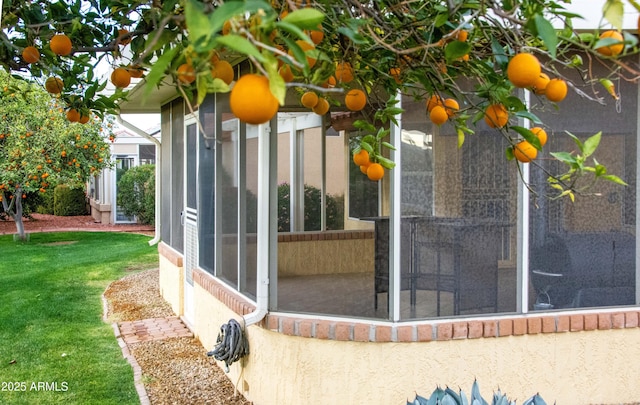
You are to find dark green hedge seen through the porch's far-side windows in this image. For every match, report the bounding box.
[278,183,344,232]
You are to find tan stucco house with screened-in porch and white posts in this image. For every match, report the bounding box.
[117,21,640,405]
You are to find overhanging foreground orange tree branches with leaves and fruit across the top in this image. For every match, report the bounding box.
[0,0,640,196]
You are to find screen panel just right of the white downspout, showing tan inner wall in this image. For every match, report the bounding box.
[271,113,387,318]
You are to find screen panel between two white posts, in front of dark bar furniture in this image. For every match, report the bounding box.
[392,98,517,319]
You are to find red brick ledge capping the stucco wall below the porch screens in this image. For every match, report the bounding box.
[193,269,640,343]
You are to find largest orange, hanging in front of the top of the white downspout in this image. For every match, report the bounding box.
[229,73,279,125]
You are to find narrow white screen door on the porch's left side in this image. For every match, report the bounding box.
[182,117,198,321]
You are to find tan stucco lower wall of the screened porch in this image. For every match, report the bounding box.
[160,246,640,405]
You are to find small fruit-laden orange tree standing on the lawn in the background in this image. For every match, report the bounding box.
[0,73,109,239]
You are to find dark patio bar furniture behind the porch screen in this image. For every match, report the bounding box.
[372,217,502,316]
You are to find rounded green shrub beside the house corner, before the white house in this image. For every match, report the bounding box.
[117,165,156,225]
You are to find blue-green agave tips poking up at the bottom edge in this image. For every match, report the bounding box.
[407,380,547,405]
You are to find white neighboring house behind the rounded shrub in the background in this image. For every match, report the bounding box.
[87,127,160,224]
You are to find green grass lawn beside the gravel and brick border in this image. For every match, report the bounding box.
[0,232,158,405]
